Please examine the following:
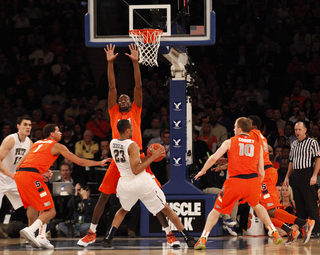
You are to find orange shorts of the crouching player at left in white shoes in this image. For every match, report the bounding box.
[14,171,54,211]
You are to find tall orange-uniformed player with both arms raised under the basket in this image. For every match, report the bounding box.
[77,44,195,247]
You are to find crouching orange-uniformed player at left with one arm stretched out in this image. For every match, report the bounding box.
[14,124,107,249]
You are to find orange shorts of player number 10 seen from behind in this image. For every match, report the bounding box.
[214,177,261,215]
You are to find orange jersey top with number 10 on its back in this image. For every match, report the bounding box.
[228,135,260,177]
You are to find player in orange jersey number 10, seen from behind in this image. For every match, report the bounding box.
[194,117,283,250]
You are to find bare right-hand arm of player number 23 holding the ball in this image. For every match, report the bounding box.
[128,143,161,175]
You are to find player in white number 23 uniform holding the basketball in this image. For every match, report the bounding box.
[101,119,195,249]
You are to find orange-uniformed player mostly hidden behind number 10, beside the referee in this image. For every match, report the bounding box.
[248,115,315,244]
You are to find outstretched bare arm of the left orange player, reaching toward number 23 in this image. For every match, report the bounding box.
[51,143,107,166]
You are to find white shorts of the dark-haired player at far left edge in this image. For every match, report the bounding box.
[0,180,23,210]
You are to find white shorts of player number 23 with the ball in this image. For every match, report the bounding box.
[117,171,166,215]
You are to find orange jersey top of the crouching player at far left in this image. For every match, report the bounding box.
[20,139,59,174]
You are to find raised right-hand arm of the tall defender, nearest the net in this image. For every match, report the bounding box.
[126,44,143,108]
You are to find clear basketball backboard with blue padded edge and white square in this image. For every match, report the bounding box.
[85,0,215,47]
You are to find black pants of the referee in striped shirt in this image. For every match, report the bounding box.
[292,167,320,232]
